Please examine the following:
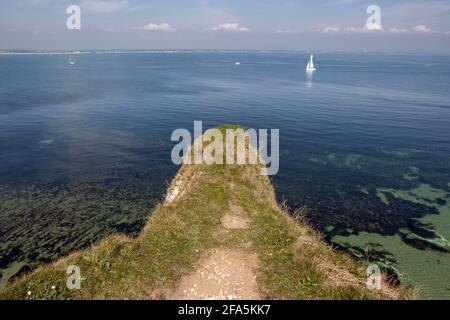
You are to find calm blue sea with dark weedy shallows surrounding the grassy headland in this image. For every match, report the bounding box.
[0,52,450,298]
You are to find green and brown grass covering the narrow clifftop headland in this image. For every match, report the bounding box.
[0,127,409,299]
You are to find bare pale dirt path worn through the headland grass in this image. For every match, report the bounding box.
[172,206,261,300]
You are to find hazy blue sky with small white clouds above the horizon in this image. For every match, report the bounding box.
[0,0,450,55]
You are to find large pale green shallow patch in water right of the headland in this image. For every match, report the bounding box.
[332,182,450,299]
